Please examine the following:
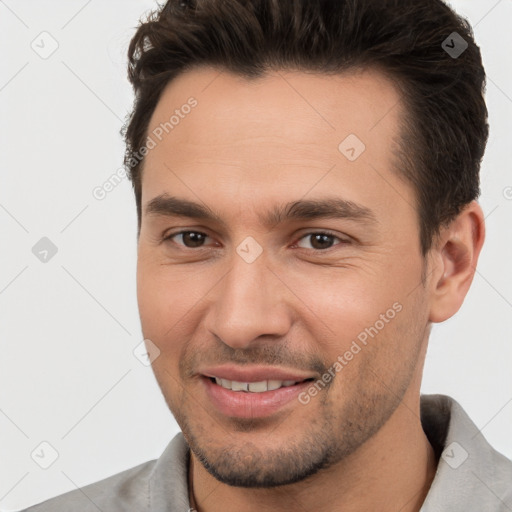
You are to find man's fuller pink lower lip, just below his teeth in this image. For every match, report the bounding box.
[201,377,311,418]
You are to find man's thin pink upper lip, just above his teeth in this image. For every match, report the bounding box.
[199,365,314,382]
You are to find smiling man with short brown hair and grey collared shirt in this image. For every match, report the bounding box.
[23,0,512,512]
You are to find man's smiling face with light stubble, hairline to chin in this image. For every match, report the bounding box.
[137,68,429,486]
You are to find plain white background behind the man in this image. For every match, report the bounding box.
[0,0,512,511]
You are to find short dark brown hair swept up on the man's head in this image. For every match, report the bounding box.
[122,0,489,255]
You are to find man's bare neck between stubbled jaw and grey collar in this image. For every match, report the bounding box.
[189,388,437,512]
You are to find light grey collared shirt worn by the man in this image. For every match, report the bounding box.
[20,395,512,512]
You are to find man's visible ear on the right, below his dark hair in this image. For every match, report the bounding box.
[429,201,485,322]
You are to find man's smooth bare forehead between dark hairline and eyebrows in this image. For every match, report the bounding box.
[142,67,412,221]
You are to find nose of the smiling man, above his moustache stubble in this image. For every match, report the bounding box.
[206,250,292,349]
